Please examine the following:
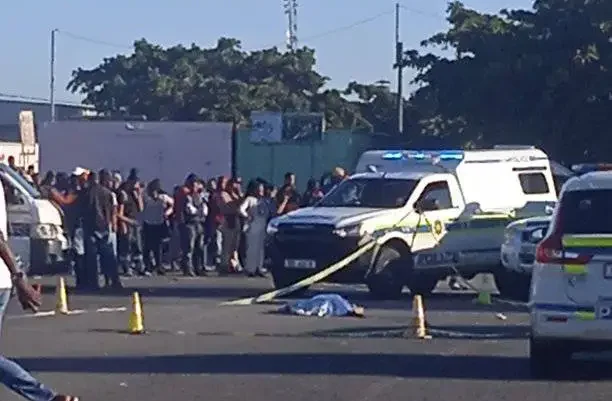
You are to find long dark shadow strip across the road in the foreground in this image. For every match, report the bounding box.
[19,353,610,381]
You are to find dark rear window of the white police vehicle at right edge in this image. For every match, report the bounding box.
[560,189,612,234]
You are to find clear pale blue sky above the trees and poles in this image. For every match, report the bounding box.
[0,0,532,101]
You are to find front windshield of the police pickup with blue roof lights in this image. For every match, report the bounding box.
[316,178,418,209]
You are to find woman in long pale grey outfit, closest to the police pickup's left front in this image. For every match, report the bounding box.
[238,181,270,277]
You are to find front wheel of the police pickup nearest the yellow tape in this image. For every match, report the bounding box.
[366,246,404,299]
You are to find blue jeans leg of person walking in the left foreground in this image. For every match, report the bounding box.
[0,289,57,401]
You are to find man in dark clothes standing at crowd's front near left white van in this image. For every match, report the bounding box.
[79,172,122,289]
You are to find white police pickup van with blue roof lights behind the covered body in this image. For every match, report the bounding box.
[265,146,556,298]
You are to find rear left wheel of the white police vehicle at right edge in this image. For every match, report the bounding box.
[529,338,572,379]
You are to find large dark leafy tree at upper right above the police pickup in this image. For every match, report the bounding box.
[406,0,612,160]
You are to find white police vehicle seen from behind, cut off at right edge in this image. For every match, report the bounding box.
[529,171,612,377]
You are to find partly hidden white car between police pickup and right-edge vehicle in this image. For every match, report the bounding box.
[495,216,551,301]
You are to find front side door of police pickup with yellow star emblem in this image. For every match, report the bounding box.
[412,180,460,267]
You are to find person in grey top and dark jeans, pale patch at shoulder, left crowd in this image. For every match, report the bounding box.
[142,179,174,275]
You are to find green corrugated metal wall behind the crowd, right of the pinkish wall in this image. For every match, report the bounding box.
[235,130,390,189]
